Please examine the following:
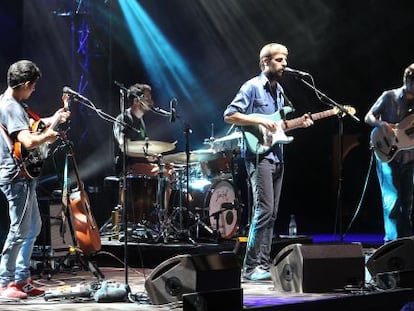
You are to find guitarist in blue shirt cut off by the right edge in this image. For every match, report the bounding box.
[365,63,414,242]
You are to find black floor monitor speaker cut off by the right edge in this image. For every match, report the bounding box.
[367,236,414,277]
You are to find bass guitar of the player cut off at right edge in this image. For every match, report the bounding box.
[371,114,414,162]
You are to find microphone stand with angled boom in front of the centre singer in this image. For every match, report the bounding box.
[295,74,360,243]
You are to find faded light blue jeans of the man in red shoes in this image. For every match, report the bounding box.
[0,180,42,286]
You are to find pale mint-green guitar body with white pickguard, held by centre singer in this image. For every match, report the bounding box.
[242,107,293,154]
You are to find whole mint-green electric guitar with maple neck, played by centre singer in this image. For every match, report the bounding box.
[241,106,356,154]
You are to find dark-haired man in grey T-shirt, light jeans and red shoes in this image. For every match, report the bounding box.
[0,60,70,299]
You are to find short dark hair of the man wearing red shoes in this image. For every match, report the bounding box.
[7,60,42,89]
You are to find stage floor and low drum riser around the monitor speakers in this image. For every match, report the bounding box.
[9,235,414,311]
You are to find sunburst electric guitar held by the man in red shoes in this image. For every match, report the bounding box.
[13,107,67,179]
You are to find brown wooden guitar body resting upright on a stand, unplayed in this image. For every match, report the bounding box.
[69,189,101,255]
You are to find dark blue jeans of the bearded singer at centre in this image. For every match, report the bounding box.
[243,159,284,275]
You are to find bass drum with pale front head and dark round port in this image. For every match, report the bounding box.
[171,179,238,239]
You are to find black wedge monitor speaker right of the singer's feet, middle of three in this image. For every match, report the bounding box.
[270,243,365,293]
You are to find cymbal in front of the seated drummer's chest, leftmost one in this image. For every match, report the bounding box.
[121,140,177,157]
